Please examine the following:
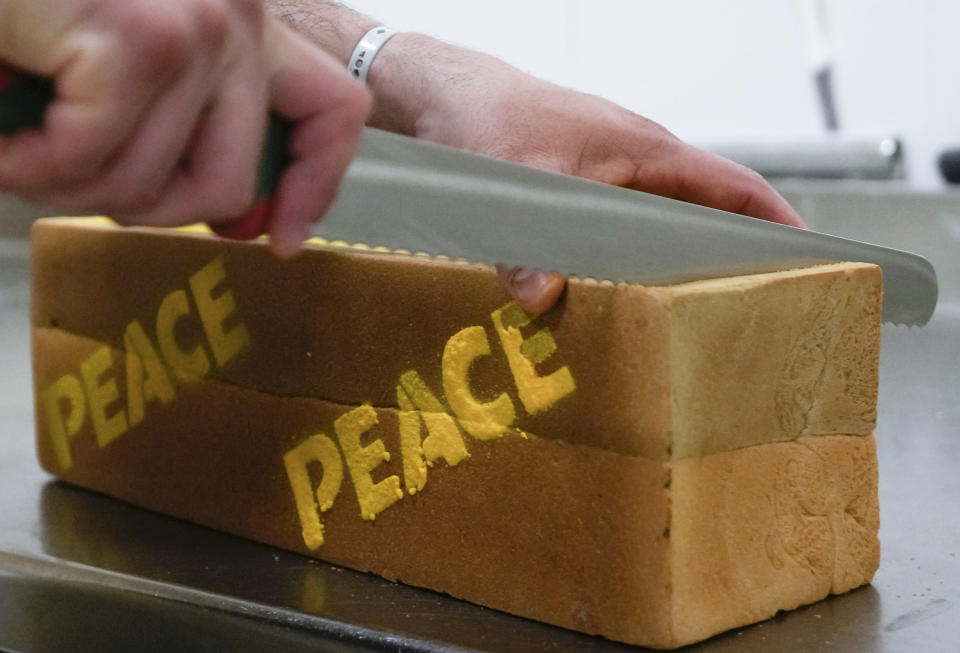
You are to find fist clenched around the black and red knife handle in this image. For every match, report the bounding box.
[0,0,369,255]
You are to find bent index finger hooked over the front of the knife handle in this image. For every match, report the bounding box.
[267,23,370,256]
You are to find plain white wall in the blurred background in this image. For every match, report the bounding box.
[347,0,960,188]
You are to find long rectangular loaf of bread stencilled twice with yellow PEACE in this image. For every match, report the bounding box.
[32,219,881,648]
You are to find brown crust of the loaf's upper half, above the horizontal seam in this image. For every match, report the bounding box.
[32,220,881,460]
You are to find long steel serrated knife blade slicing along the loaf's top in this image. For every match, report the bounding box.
[312,129,937,325]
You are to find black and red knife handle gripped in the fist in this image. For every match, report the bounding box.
[0,62,292,240]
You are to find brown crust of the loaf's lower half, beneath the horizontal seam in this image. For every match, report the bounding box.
[34,328,879,648]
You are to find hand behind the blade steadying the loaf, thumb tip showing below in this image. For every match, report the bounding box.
[371,34,806,312]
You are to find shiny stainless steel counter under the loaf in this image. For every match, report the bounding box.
[0,211,960,653]
